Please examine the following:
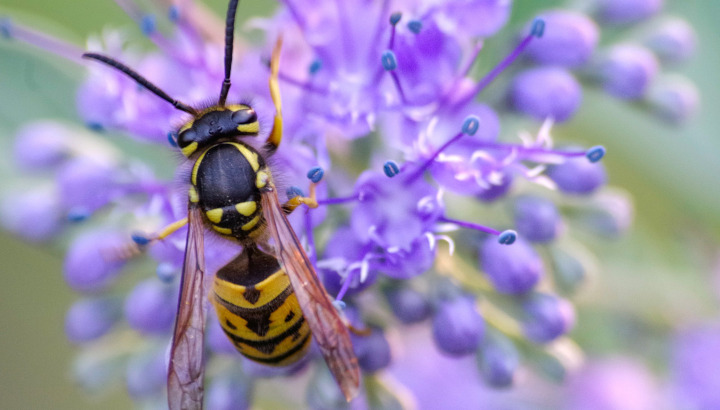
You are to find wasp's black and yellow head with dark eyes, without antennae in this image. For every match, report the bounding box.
[177,105,260,156]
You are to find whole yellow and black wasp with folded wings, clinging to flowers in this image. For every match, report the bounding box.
[83,0,360,410]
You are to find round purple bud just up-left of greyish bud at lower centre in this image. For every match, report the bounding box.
[432,296,485,356]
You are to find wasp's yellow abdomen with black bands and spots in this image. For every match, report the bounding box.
[210,248,311,366]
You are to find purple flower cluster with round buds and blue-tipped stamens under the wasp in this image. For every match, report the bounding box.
[0,0,698,409]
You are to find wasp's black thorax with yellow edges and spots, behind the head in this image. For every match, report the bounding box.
[192,142,265,240]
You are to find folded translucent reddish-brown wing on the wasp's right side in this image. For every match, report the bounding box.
[262,188,360,401]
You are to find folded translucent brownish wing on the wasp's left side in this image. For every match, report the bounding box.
[168,202,206,410]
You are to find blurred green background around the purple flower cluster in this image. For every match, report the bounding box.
[0,0,720,409]
